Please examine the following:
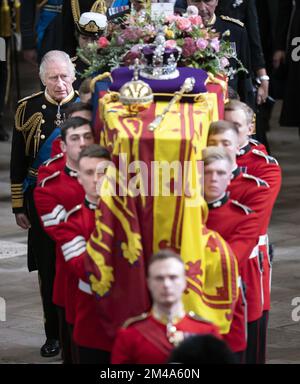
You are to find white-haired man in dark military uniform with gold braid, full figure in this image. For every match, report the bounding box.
[10,51,77,356]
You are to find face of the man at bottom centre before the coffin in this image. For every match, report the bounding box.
[148,258,186,307]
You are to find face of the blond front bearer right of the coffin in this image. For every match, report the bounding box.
[204,160,231,203]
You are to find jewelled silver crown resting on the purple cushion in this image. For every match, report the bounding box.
[140,32,182,80]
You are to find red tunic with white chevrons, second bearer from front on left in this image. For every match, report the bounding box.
[34,167,84,324]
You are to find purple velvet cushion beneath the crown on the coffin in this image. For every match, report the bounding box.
[109,67,208,94]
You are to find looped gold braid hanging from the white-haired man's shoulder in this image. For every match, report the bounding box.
[15,101,43,157]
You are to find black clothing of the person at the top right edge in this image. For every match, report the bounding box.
[275,0,300,127]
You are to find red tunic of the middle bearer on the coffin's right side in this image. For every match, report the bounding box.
[228,169,271,322]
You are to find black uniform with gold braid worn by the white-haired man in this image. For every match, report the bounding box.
[10,91,77,339]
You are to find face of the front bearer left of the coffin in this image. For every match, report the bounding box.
[78,157,107,202]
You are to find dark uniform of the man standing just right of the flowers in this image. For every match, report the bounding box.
[212,16,254,107]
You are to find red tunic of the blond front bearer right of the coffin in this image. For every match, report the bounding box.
[206,195,259,352]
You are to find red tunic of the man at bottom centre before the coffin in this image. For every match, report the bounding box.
[111,314,221,364]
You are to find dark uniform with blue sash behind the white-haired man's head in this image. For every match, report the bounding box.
[21,0,63,62]
